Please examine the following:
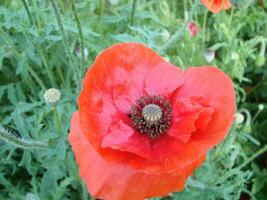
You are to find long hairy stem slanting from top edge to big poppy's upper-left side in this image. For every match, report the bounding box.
[50,0,81,89]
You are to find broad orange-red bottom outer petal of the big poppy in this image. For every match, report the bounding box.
[69,112,205,200]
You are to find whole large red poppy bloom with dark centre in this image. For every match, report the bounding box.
[69,43,235,200]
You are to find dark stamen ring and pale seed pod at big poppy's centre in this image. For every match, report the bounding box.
[130,96,171,139]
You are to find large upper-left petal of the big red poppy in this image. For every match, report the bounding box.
[78,43,169,147]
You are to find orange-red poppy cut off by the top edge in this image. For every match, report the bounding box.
[201,0,231,14]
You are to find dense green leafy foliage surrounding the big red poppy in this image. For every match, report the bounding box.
[0,0,267,200]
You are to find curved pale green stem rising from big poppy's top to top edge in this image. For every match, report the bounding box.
[160,1,199,53]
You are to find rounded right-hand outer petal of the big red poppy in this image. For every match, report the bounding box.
[177,66,235,150]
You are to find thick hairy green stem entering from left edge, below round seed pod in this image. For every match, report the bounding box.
[0,128,48,149]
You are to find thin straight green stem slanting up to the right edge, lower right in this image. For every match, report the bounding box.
[215,145,267,185]
